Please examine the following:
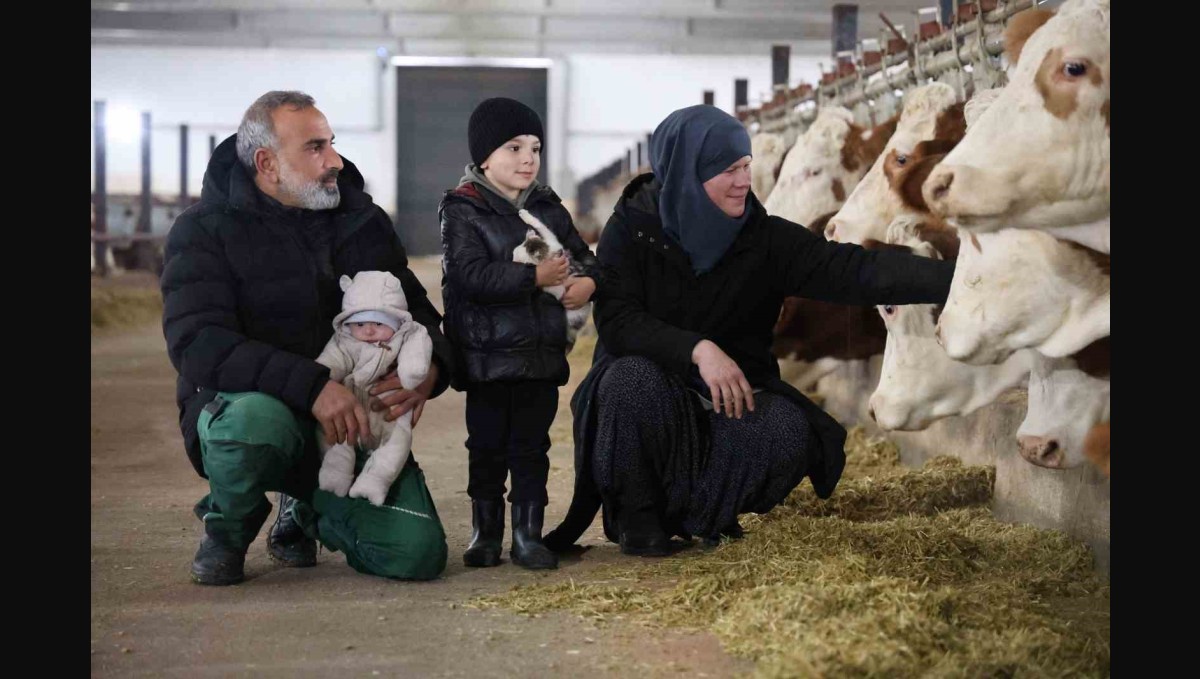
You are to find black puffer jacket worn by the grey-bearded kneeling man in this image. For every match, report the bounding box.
[161,136,454,476]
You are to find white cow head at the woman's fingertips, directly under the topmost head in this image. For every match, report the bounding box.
[937,227,1111,365]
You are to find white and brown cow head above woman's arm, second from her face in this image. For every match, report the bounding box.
[826,83,965,244]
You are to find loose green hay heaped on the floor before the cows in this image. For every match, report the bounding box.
[472,429,1110,678]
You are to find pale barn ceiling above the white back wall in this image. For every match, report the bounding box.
[91,0,936,56]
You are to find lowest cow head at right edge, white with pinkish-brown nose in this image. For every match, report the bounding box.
[1016,347,1110,469]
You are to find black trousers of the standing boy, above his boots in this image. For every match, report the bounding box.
[467,380,558,506]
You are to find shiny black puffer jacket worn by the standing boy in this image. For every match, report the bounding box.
[438,182,602,391]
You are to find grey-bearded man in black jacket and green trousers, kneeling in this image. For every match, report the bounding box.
[162,91,452,585]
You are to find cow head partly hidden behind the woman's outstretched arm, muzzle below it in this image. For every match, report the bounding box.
[864,215,1031,431]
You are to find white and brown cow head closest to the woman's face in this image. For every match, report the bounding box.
[763,106,899,233]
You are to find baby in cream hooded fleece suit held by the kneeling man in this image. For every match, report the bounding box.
[317,271,433,505]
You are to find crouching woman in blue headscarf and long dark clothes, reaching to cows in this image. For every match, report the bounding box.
[545,106,954,555]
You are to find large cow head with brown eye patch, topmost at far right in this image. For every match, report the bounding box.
[923,0,1110,232]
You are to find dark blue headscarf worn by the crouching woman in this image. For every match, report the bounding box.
[650,104,750,275]
